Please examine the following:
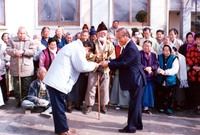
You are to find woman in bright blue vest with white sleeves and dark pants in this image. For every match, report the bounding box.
[156,45,179,115]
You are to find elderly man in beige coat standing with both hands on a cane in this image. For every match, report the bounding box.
[6,26,36,108]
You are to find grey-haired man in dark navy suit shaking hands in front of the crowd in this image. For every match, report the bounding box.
[101,28,146,133]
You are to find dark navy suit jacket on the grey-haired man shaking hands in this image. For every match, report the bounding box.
[108,40,146,90]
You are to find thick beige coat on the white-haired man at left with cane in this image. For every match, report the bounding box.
[6,37,36,77]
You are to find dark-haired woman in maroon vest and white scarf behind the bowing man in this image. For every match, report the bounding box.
[39,38,60,70]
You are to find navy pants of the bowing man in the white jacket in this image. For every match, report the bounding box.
[47,86,69,134]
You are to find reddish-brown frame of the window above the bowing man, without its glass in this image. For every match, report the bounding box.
[38,0,80,26]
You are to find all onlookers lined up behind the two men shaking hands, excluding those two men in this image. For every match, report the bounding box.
[0,20,200,118]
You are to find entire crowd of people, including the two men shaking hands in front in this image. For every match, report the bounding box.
[0,20,200,135]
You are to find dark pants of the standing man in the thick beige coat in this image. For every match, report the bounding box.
[13,76,33,103]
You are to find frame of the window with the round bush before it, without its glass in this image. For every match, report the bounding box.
[113,0,150,26]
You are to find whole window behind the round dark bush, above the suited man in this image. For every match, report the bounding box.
[113,0,150,25]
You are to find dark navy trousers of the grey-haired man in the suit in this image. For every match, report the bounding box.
[125,79,145,132]
